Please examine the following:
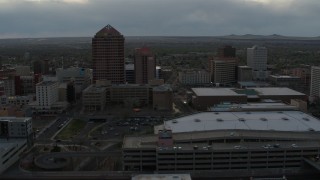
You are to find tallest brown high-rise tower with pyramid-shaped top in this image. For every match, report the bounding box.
[92,25,125,84]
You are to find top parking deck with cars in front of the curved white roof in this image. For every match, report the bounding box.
[123,130,320,150]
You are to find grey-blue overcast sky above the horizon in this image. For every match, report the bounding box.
[0,0,320,38]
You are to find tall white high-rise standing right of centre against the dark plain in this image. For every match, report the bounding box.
[247,46,270,80]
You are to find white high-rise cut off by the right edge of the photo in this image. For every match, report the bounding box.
[310,66,320,97]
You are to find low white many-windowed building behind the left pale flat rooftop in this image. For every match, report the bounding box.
[179,71,211,85]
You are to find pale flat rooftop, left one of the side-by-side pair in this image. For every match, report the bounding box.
[192,88,246,96]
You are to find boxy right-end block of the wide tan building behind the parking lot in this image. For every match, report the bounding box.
[152,84,173,111]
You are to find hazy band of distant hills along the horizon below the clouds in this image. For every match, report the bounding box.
[0,34,320,45]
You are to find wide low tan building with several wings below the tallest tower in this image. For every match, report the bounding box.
[82,81,173,111]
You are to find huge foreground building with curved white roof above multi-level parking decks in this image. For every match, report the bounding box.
[122,111,320,177]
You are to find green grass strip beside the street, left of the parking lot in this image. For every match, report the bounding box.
[55,119,87,140]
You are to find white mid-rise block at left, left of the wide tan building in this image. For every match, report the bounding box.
[36,81,59,109]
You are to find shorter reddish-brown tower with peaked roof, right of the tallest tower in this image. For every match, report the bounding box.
[134,47,156,84]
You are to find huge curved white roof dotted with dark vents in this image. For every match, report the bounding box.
[155,111,320,133]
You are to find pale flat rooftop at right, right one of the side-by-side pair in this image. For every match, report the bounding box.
[250,87,305,96]
